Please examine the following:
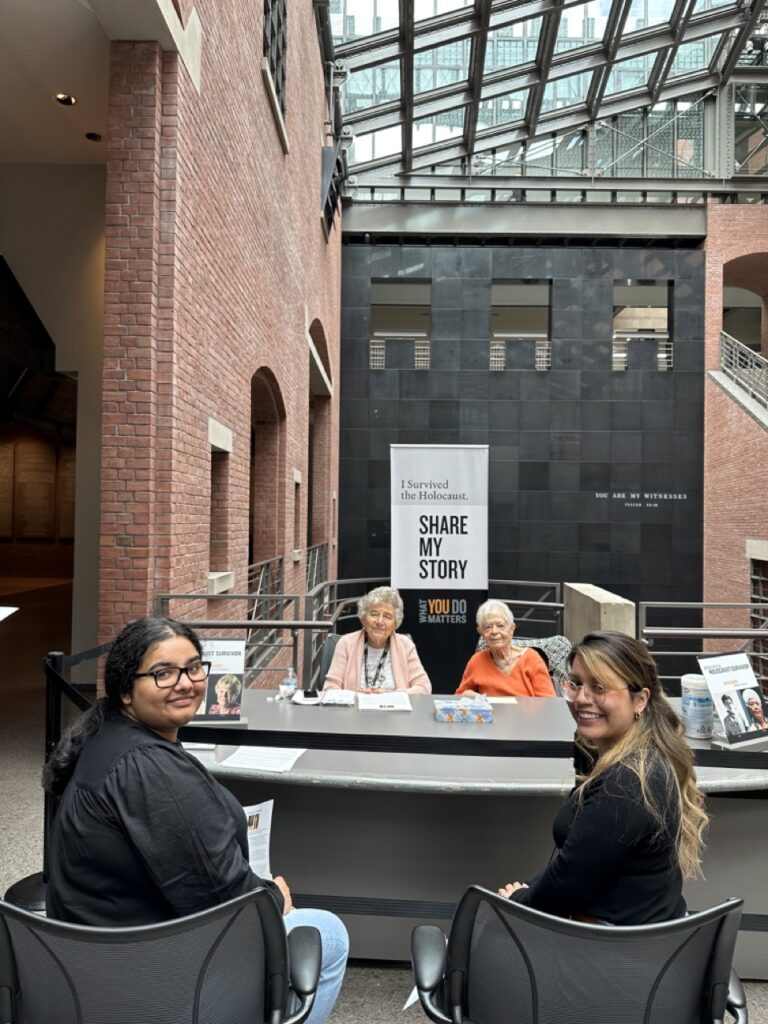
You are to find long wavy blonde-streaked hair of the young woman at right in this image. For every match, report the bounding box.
[568,630,709,878]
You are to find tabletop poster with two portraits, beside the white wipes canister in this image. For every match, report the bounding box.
[697,652,768,745]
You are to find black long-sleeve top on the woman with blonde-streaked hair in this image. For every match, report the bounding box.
[512,764,686,925]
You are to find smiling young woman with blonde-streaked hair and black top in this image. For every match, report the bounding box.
[499,632,708,925]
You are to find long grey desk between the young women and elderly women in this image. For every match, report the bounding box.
[181,690,768,978]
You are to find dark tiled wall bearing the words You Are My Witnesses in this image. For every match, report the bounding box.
[339,244,703,601]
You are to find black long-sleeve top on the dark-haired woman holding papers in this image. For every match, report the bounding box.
[46,714,283,927]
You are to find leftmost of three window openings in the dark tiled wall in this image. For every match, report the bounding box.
[369,281,431,370]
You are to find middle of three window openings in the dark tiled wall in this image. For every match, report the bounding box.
[488,278,552,372]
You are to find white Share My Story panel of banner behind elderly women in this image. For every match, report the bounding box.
[390,444,488,591]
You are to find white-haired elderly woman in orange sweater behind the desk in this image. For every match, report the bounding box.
[456,598,557,697]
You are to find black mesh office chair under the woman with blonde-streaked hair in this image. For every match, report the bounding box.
[412,886,749,1024]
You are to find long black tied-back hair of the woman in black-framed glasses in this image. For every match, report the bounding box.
[43,618,202,796]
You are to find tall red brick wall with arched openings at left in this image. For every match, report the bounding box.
[99,0,340,637]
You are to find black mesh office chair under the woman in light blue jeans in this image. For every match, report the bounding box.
[0,889,322,1024]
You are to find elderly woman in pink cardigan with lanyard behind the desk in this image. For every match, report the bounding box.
[325,587,432,693]
